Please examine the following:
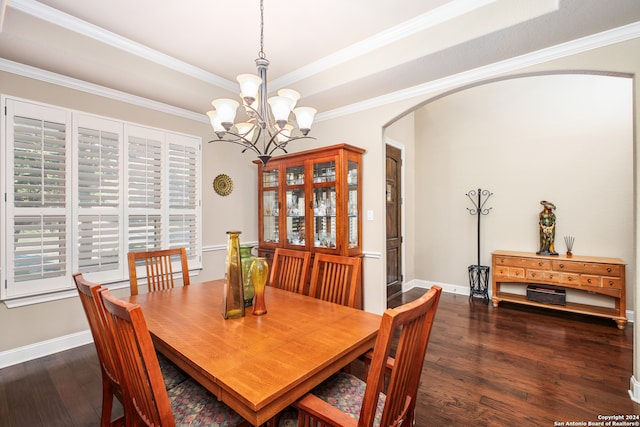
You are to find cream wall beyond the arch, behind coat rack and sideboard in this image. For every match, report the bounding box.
[407,74,634,305]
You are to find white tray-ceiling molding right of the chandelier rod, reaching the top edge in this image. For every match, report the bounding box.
[270,0,497,89]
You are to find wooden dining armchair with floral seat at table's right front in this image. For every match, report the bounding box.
[289,286,442,427]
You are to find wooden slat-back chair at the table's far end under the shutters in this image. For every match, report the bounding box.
[128,248,190,295]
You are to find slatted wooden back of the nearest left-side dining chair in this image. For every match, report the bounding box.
[99,289,175,427]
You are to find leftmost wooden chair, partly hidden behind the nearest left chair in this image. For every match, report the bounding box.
[73,273,124,427]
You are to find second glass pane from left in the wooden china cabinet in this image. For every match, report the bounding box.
[285,166,307,246]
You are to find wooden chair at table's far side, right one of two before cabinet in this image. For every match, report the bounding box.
[309,253,362,307]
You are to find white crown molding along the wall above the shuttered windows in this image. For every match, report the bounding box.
[0,58,209,123]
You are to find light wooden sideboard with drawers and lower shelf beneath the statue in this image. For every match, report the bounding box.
[491,251,627,329]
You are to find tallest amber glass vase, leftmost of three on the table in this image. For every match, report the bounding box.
[222,231,244,319]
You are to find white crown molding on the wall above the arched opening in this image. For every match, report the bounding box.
[315,22,640,122]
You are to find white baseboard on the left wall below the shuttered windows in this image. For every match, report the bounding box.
[0,329,93,369]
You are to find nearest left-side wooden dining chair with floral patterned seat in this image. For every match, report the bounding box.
[98,288,250,427]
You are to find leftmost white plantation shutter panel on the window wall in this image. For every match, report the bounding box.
[5,100,71,297]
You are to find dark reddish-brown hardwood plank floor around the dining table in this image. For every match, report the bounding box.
[0,289,640,427]
